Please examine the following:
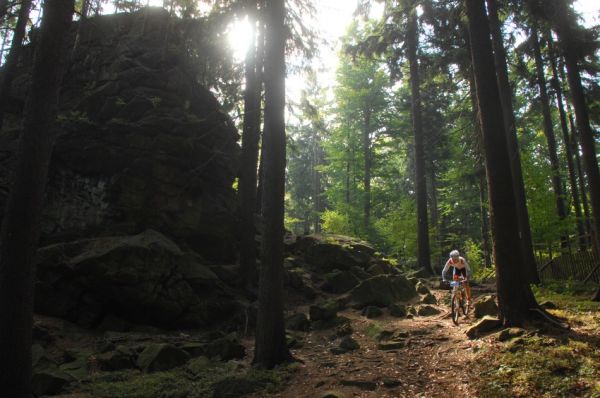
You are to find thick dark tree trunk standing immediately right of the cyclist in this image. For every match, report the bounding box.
[465,0,537,325]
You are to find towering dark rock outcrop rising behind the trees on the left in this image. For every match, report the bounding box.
[0,8,239,261]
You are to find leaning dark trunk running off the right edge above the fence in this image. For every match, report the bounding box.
[554,2,600,253]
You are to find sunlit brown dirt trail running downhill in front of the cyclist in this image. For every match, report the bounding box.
[260,290,490,398]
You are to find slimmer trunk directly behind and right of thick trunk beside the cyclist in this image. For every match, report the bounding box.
[487,0,540,284]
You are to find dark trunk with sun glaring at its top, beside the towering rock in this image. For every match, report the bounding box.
[238,0,261,289]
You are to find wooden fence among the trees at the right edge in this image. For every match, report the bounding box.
[538,251,600,283]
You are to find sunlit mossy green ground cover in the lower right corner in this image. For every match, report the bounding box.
[476,282,600,398]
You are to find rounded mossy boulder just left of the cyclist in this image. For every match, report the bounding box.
[350,275,419,308]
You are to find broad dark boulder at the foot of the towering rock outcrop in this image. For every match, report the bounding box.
[35,230,237,328]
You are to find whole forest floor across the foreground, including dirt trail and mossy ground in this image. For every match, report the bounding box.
[50,282,600,398]
